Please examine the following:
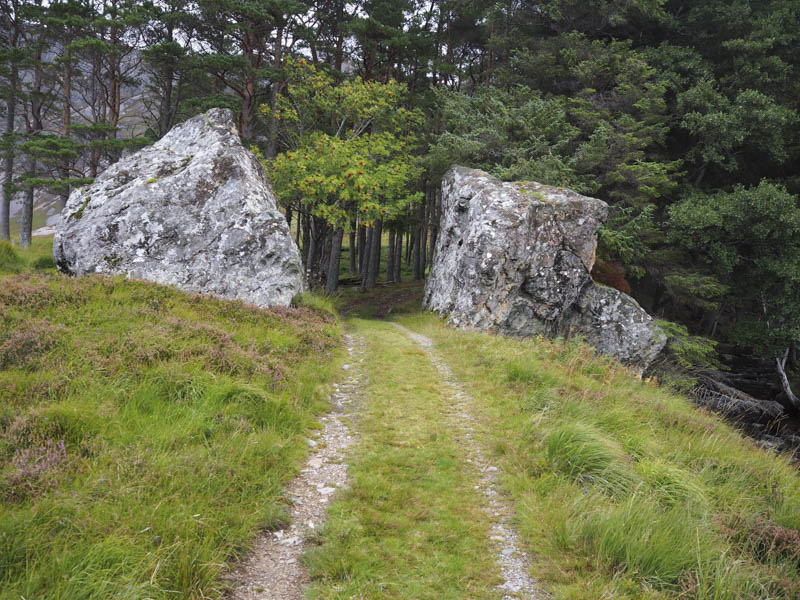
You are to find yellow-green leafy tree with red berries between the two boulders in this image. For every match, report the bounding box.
[262,59,423,293]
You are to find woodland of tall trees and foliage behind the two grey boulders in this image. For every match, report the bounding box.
[0,0,800,394]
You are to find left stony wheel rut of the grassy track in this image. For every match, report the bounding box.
[228,335,363,600]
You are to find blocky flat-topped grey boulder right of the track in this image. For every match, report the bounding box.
[424,166,666,373]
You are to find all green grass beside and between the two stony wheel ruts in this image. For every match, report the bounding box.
[9,241,800,600]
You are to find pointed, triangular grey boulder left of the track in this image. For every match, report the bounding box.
[53,109,304,306]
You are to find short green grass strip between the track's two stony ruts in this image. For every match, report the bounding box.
[306,320,500,600]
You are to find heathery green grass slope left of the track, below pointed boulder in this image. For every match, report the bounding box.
[0,240,340,600]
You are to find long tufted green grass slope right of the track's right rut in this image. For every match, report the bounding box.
[396,304,800,600]
